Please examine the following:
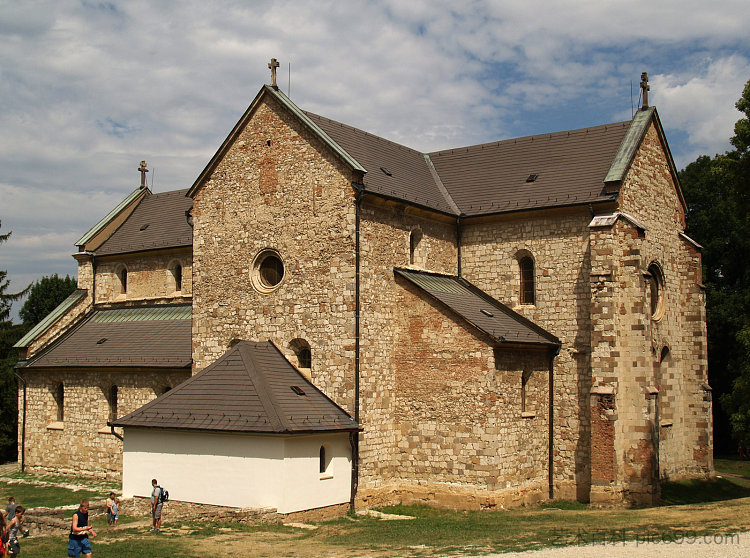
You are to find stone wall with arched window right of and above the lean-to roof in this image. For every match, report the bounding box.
[462,208,591,500]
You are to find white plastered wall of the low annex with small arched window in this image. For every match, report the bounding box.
[122,428,351,513]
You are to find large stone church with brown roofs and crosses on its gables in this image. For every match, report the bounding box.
[17,68,713,508]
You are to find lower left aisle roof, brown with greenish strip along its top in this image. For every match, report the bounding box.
[26,304,193,368]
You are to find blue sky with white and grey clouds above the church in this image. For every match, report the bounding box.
[0,0,750,322]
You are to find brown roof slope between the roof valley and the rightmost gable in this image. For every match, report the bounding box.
[430,122,630,215]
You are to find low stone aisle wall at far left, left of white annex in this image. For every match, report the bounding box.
[18,369,190,480]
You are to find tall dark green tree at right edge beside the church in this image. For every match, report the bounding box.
[680,81,750,451]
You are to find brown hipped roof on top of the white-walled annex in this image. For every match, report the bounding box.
[114,341,358,434]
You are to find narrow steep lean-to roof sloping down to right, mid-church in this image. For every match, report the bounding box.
[394,268,560,346]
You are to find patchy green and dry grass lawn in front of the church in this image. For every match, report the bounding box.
[8,463,750,558]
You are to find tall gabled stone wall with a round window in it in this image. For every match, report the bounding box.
[193,96,355,422]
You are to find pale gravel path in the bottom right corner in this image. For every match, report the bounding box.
[444,532,750,558]
